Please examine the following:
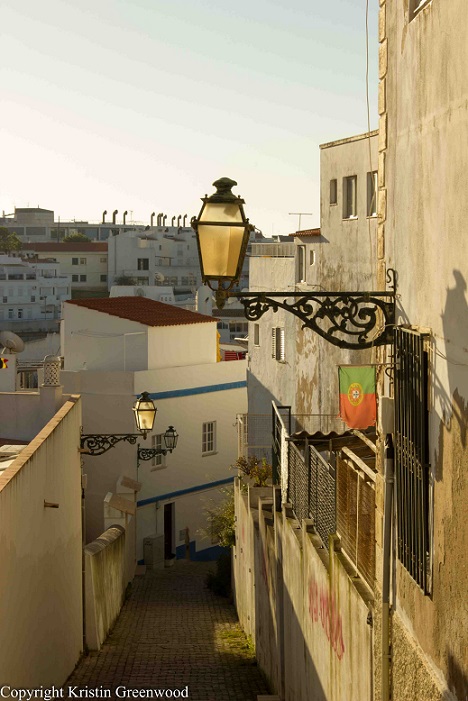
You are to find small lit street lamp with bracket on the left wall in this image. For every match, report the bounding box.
[80,392,157,455]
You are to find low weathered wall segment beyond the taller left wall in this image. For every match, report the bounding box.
[84,526,127,650]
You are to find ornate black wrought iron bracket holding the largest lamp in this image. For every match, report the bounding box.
[228,269,396,350]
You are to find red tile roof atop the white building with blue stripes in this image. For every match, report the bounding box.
[65,297,217,326]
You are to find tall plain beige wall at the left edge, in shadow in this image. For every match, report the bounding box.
[0,397,82,688]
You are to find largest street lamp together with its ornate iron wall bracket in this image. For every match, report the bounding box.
[191,178,396,350]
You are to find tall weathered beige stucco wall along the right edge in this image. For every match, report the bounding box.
[379,0,468,699]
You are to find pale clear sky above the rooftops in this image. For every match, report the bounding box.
[0,0,378,236]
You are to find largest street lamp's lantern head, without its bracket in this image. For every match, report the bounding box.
[192,178,253,309]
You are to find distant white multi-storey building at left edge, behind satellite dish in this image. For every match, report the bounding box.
[0,255,71,330]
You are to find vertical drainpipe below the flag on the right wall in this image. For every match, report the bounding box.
[382,433,395,701]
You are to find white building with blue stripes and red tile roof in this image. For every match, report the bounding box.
[61,297,246,558]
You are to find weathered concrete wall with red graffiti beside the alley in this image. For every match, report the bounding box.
[234,484,372,701]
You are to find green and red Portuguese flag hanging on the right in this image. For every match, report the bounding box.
[338,365,376,428]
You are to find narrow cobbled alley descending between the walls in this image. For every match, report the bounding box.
[64,561,268,701]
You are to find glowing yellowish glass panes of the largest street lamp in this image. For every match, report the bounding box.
[197,202,248,280]
